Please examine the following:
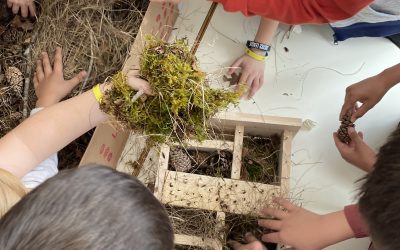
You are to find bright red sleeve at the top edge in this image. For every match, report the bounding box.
[212,0,373,24]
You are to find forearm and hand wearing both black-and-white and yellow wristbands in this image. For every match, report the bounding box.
[228,18,279,99]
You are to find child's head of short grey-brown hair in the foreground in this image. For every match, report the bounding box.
[0,166,173,250]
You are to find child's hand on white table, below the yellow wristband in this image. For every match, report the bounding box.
[228,55,265,99]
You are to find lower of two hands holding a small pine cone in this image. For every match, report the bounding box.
[333,128,376,172]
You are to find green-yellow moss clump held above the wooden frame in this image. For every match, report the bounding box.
[101,36,244,140]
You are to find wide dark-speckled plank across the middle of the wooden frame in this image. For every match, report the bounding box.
[159,170,281,214]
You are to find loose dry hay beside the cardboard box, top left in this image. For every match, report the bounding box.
[32,0,147,94]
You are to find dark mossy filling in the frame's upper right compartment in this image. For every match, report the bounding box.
[241,134,281,184]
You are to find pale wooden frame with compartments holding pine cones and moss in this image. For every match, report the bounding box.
[155,113,302,250]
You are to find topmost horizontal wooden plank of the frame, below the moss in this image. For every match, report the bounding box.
[210,112,302,136]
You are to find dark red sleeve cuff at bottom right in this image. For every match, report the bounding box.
[344,205,375,250]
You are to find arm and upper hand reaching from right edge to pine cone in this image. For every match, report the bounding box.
[339,64,400,121]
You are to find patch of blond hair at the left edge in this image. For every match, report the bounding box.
[0,168,28,218]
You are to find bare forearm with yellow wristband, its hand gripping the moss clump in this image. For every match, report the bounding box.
[0,49,147,178]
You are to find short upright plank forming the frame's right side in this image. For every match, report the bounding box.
[279,130,294,194]
